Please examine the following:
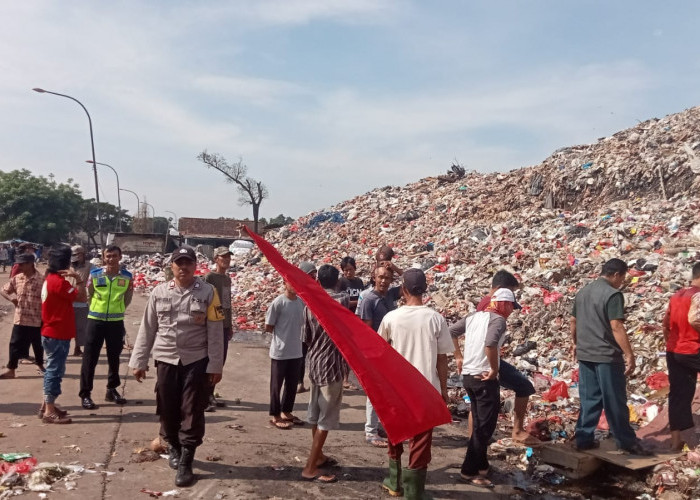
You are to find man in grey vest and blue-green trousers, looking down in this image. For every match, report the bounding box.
[570,259,652,455]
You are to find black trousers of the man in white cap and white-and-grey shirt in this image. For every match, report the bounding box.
[462,375,501,476]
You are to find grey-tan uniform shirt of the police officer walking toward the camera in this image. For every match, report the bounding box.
[129,277,224,373]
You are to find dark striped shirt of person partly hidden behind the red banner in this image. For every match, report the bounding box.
[302,289,350,386]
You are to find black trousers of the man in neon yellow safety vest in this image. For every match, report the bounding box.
[79,318,126,398]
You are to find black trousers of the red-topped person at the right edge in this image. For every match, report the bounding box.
[666,351,700,431]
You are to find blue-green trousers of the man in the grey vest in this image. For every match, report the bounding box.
[576,361,637,449]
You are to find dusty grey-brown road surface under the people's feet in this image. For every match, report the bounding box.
[0,274,517,499]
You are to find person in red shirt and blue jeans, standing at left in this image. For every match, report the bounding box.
[41,245,87,424]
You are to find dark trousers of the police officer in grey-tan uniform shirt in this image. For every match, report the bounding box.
[155,358,209,448]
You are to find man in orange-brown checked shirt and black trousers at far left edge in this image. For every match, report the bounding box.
[0,253,44,379]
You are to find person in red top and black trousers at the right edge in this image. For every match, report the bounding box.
[664,262,700,451]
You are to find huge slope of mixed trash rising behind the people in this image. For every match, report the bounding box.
[234,104,700,390]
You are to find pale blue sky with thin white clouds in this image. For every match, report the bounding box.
[0,0,700,218]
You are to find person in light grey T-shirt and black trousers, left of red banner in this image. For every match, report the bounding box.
[265,281,304,429]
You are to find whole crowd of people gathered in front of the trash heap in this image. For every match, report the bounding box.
[0,240,700,498]
